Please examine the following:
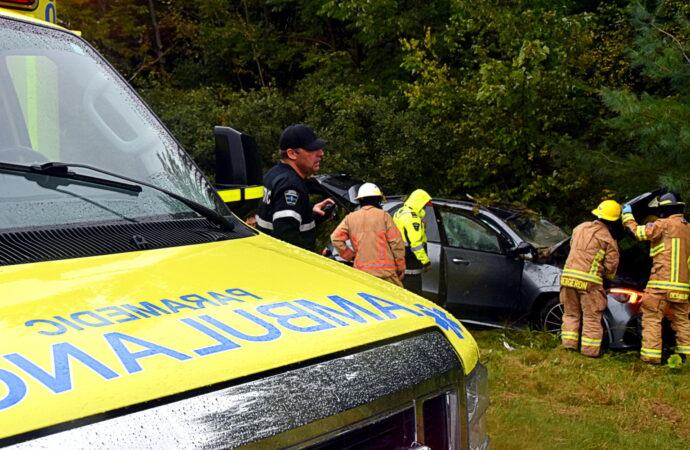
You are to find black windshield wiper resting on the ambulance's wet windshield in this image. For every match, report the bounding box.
[0,162,235,231]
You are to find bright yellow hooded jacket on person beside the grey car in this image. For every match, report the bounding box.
[393,189,431,273]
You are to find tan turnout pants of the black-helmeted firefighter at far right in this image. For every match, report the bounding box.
[640,289,690,364]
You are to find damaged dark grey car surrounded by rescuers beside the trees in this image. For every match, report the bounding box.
[313,175,646,350]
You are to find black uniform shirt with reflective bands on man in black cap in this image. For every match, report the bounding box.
[256,163,316,250]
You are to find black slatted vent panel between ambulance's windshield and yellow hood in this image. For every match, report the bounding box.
[0,218,254,266]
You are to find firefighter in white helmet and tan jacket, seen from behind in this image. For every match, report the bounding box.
[331,183,405,287]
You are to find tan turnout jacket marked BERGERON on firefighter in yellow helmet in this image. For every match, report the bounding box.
[561,220,620,290]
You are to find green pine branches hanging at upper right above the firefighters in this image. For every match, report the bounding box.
[564,0,690,206]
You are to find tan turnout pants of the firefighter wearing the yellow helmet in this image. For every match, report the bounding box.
[560,283,606,357]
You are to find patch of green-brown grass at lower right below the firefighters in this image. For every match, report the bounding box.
[472,330,690,449]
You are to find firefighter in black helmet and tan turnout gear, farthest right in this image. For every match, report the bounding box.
[622,192,690,364]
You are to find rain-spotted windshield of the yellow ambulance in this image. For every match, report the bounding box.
[0,19,224,230]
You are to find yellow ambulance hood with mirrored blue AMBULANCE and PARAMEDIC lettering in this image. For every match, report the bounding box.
[0,235,478,438]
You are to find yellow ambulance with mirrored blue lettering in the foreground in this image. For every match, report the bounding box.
[0,0,488,449]
